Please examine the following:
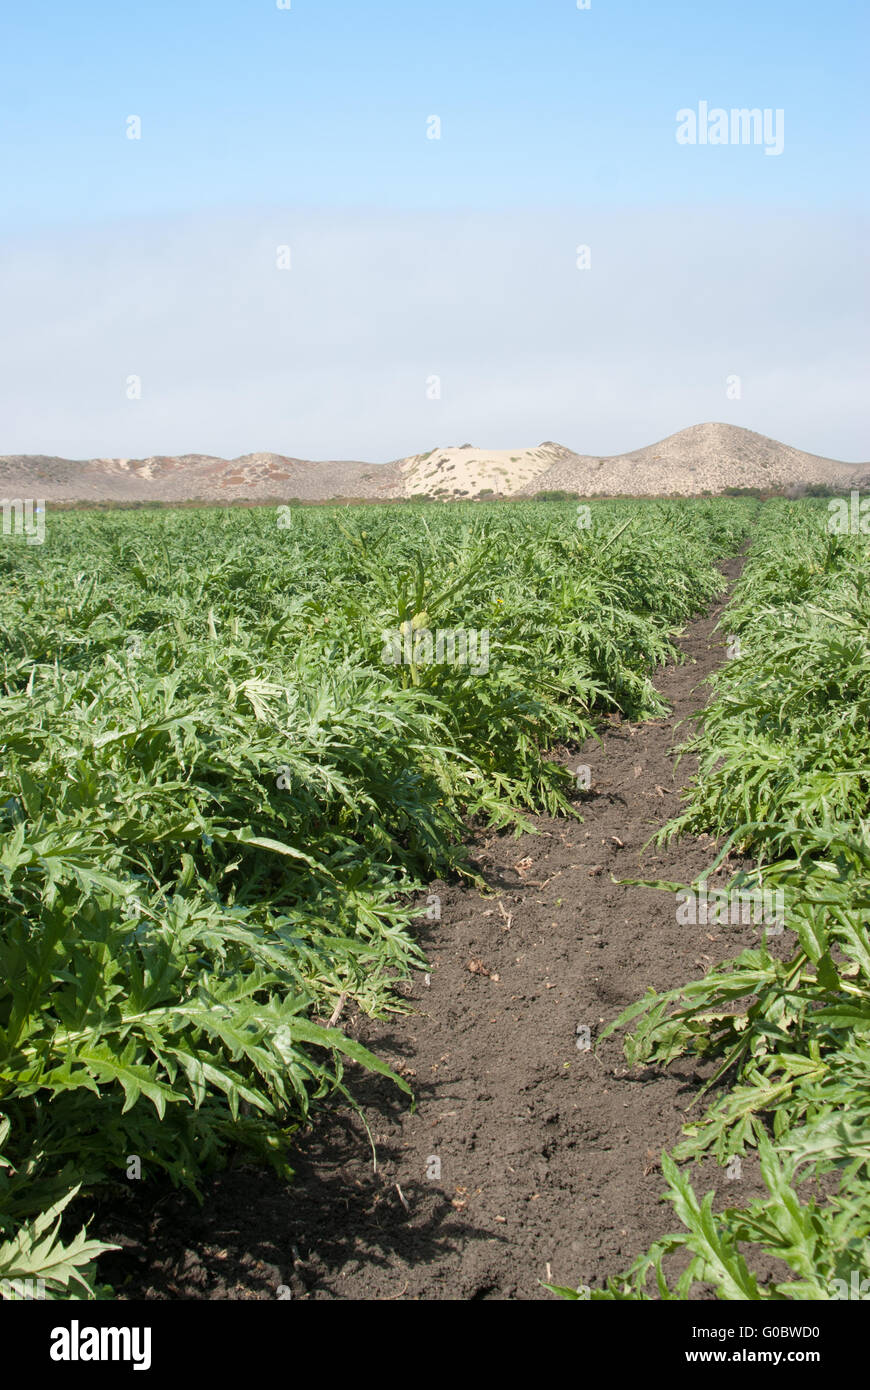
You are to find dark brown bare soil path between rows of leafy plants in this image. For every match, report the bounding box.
[97,562,794,1300]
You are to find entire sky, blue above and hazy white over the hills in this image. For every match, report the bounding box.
[0,0,870,461]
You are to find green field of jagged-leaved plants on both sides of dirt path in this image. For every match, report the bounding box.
[0,499,870,1298]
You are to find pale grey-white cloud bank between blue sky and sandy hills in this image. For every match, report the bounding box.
[0,207,870,461]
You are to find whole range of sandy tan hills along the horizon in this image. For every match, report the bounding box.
[0,424,870,502]
